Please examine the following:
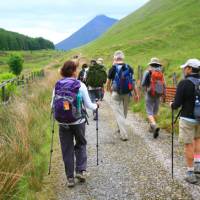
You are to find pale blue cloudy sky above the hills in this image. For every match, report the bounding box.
[0,0,148,43]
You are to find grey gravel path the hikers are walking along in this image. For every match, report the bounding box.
[44,94,200,200]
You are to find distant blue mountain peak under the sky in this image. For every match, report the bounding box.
[56,15,118,50]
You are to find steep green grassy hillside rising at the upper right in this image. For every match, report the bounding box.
[78,0,200,83]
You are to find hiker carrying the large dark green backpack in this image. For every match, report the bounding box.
[86,60,107,120]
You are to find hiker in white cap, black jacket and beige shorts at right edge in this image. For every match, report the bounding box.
[171,59,200,184]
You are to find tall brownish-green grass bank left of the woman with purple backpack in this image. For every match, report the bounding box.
[0,68,59,200]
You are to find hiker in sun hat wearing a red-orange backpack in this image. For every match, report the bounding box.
[142,58,165,138]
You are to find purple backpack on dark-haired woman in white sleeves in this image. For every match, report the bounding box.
[54,78,82,123]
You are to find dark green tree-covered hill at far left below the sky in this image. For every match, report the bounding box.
[0,28,55,50]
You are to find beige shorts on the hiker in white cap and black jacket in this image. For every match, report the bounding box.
[179,119,200,144]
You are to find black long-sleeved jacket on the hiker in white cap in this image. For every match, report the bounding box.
[172,74,200,119]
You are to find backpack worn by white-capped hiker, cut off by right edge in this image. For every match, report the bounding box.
[187,77,200,122]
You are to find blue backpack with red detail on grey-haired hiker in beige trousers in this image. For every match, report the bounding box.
[112,64,134,94]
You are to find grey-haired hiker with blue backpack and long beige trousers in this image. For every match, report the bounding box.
[107,51,139,141]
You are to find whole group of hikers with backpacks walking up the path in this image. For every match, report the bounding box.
[51,51,200,187]
